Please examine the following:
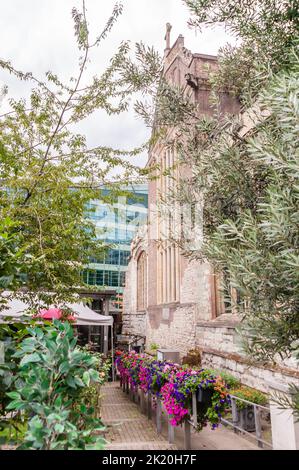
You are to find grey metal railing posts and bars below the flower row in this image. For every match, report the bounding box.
[120,377,272,450]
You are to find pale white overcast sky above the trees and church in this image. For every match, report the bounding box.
[0,0,232,167]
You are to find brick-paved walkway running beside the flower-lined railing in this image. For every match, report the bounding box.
[102,382,258,450]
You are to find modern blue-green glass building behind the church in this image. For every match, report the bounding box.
[83,184,148,309]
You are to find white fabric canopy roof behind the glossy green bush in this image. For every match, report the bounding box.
[0,299,113,326]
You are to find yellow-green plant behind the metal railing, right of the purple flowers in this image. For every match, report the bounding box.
[231,387,267,432]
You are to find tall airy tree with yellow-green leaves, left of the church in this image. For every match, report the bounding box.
[0,1,145,303]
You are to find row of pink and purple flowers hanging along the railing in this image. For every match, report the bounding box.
[115,351,229,431]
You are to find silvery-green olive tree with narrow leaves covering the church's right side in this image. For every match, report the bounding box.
[118,0,299,410]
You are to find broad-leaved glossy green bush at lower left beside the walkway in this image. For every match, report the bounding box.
[1,321,105,450]
